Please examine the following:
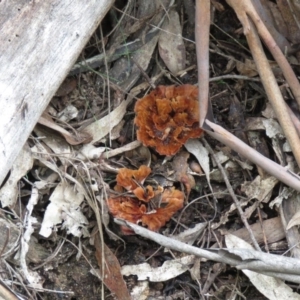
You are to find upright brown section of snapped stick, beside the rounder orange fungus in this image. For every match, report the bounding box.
[195,0,210,127]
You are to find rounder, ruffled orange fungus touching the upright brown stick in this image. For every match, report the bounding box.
[134,84,203,155]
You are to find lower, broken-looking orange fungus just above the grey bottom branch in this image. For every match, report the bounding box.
[107,166,184,234]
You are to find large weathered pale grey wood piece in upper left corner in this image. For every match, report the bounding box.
[0,0,114,184]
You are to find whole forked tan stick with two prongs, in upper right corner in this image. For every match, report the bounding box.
[227,0,300,166]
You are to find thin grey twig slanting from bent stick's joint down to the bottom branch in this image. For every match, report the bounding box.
[202,138,261,251]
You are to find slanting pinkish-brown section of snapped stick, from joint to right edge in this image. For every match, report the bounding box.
[205,120,300,192]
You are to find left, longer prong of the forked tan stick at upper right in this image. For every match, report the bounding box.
[246,20,300,166]
